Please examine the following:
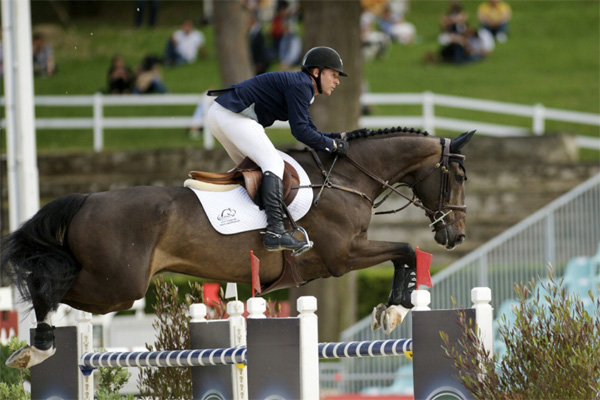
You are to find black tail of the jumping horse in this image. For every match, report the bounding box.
[0,194,88,318]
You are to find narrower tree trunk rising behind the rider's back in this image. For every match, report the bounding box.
[213,0,253,87]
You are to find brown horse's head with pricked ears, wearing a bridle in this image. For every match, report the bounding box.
[413,131,475,250]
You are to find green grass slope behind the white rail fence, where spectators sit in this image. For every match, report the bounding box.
[19,0,600,159]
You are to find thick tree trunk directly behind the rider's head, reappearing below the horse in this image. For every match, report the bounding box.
[292,0,362,341]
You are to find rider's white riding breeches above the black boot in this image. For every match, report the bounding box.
[206,102,284,179]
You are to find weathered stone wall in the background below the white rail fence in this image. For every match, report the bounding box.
[1,135,600,265]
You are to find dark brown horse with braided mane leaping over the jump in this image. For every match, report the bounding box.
[1,128,474,368]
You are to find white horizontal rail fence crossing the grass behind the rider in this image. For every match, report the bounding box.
[0,92,600,152]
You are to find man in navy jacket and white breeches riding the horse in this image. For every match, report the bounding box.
[206,47,348,251]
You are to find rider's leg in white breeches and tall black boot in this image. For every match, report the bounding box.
[207,103,308,251]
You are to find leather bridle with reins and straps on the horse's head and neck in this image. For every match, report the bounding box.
[300,138,467,232]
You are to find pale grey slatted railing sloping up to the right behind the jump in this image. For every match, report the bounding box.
[332,174,600,393]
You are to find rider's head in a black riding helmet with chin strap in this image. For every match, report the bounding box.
[302,46,348,95]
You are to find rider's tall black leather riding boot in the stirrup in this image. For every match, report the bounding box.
[261,171,308,251]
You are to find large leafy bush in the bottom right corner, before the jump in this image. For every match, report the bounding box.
[442,271,600,400]
